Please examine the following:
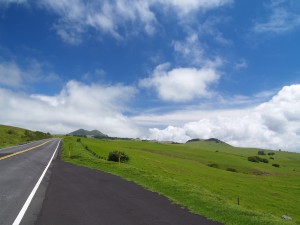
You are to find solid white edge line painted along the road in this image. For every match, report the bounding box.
[12,140,61,225]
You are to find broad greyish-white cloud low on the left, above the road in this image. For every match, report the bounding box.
[0,81,140,137]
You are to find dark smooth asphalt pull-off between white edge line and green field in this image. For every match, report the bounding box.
[36,158,220,225]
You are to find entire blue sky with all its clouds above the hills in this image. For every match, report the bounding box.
[0,0,300,151]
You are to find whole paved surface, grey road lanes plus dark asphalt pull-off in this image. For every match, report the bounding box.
[0,139,220,225]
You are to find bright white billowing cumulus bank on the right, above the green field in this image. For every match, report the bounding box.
[146,85,300,152]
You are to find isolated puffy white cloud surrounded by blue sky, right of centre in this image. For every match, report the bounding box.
[140,60,220,102]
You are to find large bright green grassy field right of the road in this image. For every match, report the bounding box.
[62,137,300,225]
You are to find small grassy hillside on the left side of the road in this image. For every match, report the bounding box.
[0,125,51,148]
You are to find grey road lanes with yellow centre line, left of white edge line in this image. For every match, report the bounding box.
[0,139,59,225]
